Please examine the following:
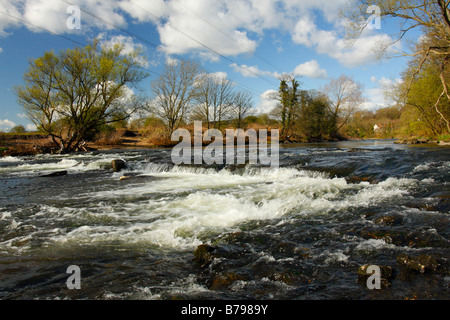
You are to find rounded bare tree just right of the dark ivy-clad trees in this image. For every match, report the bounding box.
[323,75,364,135]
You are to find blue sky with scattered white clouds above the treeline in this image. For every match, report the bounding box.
[0,0,419,131]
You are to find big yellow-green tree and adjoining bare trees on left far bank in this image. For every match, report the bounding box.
[15,41,253,152]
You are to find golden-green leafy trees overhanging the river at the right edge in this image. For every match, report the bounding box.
[342,0,450,136]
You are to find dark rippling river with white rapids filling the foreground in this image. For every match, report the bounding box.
[0,140,450,300]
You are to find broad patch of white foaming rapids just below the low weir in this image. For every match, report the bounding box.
[24,164,417,250]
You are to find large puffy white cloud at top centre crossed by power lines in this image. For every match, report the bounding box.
[157,0,257,61]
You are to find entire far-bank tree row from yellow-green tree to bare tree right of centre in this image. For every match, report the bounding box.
[16,36,361,152]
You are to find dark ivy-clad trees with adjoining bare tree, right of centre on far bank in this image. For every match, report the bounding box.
[271,75,364,141]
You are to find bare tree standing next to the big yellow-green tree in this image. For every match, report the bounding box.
[150,61,200,136]
